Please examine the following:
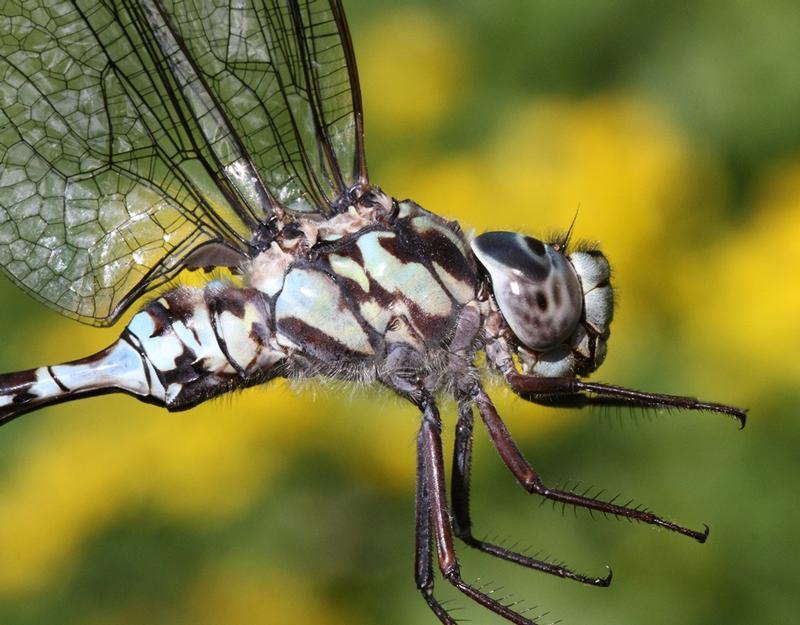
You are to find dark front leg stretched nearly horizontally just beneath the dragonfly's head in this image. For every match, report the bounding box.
[505,371,747,429]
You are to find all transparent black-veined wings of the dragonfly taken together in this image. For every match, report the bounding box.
[0,0,366,325]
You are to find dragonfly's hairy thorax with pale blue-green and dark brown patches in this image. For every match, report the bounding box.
[246,194,480,387]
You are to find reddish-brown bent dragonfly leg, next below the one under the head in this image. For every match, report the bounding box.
[475,389,709,543]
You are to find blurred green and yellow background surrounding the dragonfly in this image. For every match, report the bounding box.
[0,0,800,625]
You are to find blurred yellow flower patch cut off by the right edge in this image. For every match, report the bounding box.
[683,160,800,401]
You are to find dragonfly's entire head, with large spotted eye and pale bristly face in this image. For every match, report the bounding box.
[472,232,614,377]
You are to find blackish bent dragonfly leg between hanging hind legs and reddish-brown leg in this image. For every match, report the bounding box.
[451,399,612,586]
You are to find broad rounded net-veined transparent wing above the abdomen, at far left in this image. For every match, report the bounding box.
[0,0,258,325]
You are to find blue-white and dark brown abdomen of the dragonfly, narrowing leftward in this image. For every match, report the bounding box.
[0,282,285,423]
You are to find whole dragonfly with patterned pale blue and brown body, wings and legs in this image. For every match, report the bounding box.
[0,0,746,625]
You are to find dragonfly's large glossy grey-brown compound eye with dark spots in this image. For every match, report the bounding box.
[472,232,583,351]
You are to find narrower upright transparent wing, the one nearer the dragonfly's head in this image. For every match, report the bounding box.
[167,0,367,213]
